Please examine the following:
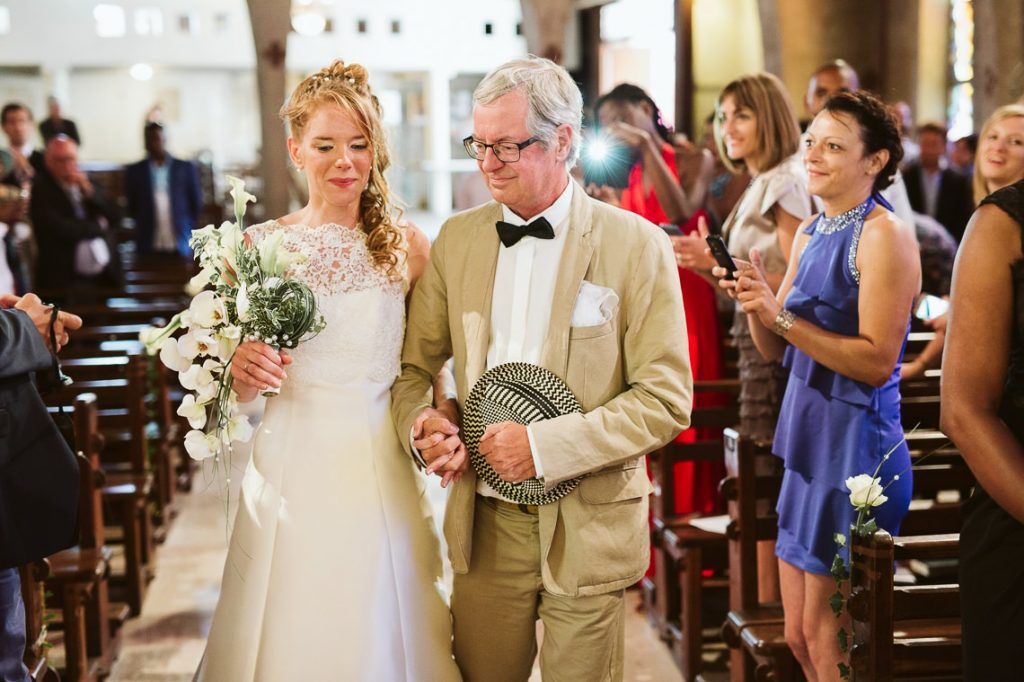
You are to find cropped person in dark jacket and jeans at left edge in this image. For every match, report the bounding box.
[0,294,82,682]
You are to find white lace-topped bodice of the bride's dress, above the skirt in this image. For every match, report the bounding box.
[246,220,407,385]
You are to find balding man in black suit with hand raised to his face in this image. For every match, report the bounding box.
[29,135,122,291]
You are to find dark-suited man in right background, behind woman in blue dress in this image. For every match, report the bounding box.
[903,123,974,242]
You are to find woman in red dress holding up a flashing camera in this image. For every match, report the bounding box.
[592,83,724,514]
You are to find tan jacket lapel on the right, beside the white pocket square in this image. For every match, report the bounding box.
[541,184,594,379]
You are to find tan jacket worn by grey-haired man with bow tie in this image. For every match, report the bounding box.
[391,186,692,596]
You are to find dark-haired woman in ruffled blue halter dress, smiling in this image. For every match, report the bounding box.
[715,92,921,681]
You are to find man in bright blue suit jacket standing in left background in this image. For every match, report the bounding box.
[125,123,203,256]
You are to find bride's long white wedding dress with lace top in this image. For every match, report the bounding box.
[196,221,460,682]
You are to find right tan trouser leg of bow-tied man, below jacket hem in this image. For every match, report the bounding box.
[540,590,626,682]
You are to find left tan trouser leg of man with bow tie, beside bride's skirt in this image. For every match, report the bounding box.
[452,496,541,682]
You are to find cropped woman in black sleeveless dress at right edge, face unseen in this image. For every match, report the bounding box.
[942,180,1024,682]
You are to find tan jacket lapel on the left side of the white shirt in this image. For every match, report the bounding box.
[461,203,502,394]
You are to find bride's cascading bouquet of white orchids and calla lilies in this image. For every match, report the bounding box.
[139,176,325,473]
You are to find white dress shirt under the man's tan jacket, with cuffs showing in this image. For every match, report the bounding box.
[476,173,572,502]
